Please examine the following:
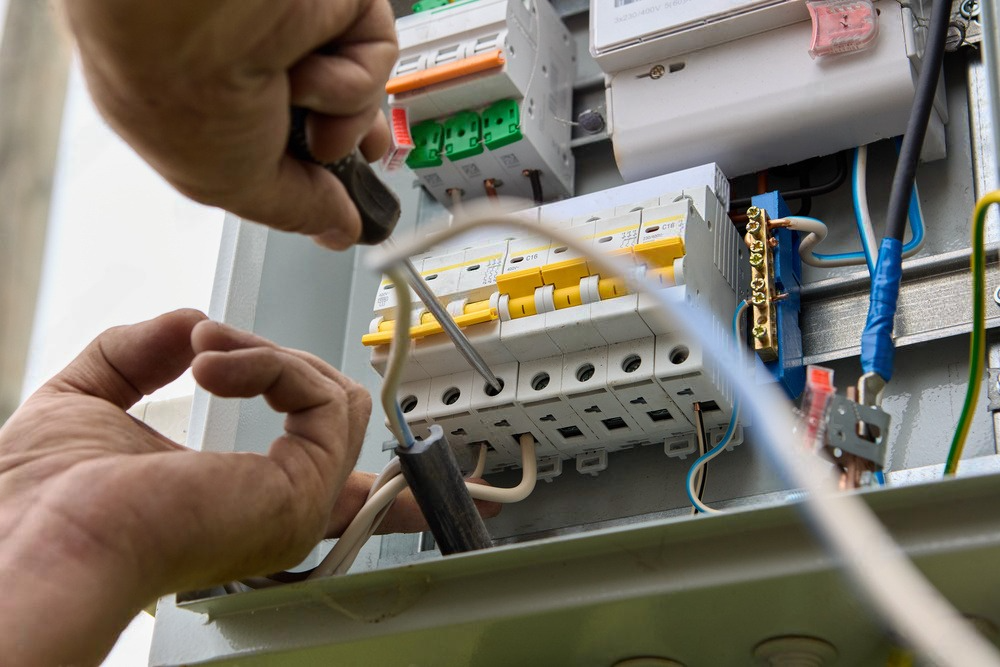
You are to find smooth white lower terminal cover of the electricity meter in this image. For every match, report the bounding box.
[607,0,947,181]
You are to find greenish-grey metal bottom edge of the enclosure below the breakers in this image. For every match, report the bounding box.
[151,476,1000,667]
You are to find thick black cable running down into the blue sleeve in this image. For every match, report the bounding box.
[883,0,951,241]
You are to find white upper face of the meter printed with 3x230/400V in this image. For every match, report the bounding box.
[590,0,809,73]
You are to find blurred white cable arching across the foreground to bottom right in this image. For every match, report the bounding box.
[372,204,1000,667]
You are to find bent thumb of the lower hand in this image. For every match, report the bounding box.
[46,309,205,409]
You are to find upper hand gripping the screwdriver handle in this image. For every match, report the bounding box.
[64,0,397,249]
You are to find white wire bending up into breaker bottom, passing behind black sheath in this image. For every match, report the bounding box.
[308,433,538,579]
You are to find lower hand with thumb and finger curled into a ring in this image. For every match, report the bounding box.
[0,310,496,665]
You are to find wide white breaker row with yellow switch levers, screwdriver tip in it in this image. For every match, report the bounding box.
[363,165,743,477]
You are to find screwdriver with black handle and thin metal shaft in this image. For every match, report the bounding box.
[288,107,503,392]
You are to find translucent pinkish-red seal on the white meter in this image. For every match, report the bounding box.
[806,0,878,58]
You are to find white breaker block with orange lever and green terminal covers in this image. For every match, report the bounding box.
[386,0,576,206]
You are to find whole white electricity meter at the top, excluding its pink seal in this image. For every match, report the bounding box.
[591,0,947,181]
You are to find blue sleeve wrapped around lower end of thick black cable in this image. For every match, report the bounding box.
[861,239,903,382]
